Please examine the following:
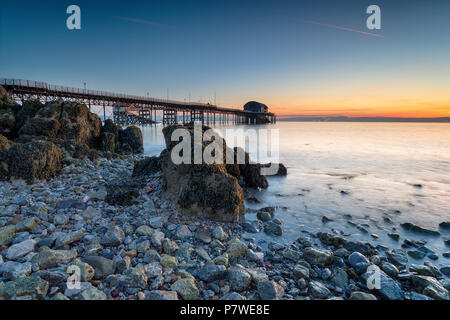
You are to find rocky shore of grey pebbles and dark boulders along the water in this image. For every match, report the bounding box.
[0,87,450,300]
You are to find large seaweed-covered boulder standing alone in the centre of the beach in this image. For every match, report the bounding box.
[160,126,245,221]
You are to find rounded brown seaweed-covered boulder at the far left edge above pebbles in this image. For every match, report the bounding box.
[3,140,62,183]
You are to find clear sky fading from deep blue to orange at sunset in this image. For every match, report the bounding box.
[0,0,450,117]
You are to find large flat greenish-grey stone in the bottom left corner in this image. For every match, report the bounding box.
[4,276,49,299]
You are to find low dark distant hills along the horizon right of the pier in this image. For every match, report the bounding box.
[277,116,450,123]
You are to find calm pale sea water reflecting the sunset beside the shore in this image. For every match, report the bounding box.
[143,122,450,264]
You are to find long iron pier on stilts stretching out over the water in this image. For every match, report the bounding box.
[0,79,276,125]
